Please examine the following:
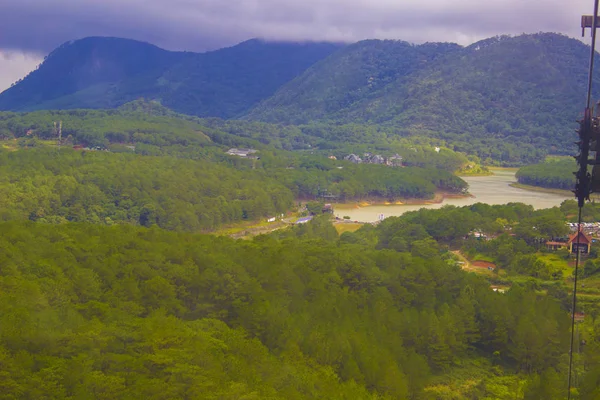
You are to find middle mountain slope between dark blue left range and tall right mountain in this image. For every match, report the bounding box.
[249,40,462,123]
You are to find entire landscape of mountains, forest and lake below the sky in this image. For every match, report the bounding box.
[0,29,600,400]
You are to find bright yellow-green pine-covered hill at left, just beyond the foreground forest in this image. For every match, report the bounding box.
[0,148,293,231]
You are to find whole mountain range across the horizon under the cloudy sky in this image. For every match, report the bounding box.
[0,33,600,166]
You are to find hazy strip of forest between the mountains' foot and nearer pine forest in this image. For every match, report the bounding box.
[0,104,476,167]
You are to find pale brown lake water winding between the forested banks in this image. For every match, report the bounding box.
[335,170,574,222]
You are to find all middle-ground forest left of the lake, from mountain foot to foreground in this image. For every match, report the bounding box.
[0,102,467,232]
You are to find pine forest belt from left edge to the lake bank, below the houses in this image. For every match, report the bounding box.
[0,147,467,232]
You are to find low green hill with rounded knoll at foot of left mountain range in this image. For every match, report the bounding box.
[0,102,256,152]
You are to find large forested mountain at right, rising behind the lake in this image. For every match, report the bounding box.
[247,33,600,151]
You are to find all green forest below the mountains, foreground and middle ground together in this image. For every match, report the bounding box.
[0,119,600,400]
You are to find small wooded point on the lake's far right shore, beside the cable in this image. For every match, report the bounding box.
[516,158,577,190]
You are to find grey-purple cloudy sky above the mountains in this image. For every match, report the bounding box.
[0,0,593,91]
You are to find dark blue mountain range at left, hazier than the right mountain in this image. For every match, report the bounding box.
[0,37,341,118]
